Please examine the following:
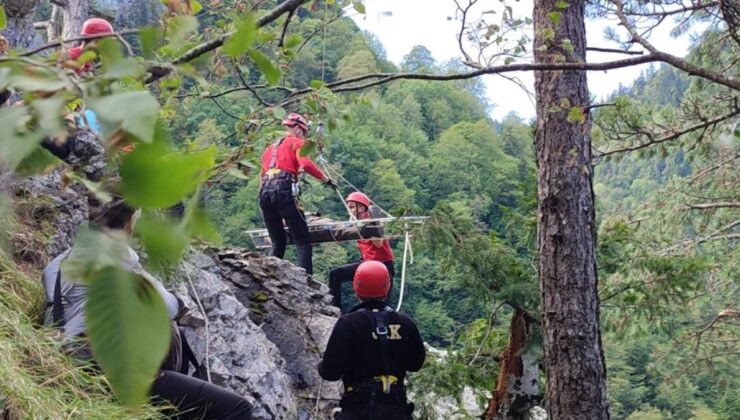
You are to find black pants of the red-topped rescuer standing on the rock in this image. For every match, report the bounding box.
[259,180,313,274]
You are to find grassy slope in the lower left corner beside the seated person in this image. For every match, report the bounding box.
[0,198,162,420]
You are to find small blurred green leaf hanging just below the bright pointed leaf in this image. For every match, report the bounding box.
[136,211,188,267]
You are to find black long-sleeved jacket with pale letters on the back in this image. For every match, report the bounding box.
[319,300,426,387]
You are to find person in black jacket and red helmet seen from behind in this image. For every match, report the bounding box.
[319,261,426,420]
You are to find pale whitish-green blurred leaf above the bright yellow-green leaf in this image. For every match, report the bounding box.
[88,90,159,142]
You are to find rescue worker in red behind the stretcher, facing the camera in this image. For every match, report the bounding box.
[329,192,395,308]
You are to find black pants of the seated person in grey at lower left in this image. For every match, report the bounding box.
[151,370,252,420]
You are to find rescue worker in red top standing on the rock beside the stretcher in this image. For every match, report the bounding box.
[259,113,336,274]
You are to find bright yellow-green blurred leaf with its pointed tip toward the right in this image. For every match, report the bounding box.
[121,143,216,208]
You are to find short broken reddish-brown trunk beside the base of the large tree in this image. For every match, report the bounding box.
[485,309,540,420]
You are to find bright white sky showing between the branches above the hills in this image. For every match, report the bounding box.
[352,0,704,120]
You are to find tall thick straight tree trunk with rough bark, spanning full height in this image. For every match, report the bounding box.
[534,0,609,420]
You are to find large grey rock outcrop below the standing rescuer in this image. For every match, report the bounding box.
[171,249,340,419]
